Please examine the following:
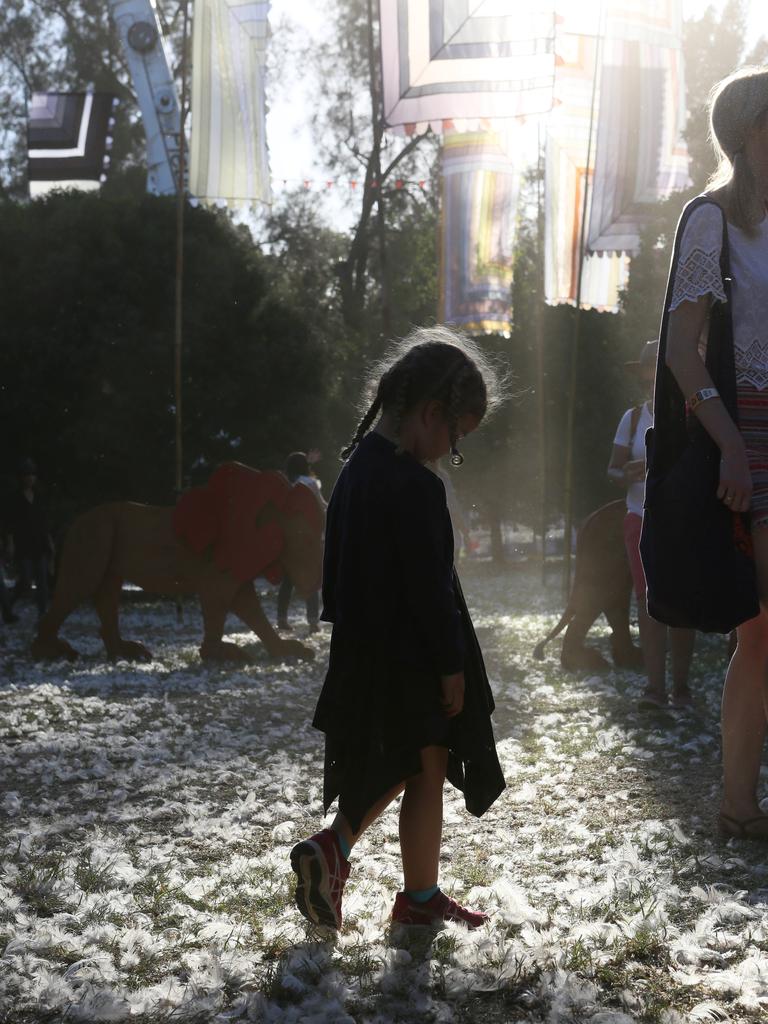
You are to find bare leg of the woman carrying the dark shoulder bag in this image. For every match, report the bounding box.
[721,529,768,820]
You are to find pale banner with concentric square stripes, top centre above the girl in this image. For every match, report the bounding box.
[381,0,555,133]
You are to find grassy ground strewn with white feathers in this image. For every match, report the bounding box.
[0,562,768,1024]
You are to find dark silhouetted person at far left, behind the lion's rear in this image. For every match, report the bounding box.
[7,459,53,618]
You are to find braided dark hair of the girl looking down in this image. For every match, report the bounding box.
[341,327,504,461]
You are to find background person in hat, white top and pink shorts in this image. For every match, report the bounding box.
[608,341,695,709]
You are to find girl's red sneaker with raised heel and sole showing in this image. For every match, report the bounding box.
[291,828,349,928]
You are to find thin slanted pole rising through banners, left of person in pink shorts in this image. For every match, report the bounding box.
[563,0,603,599]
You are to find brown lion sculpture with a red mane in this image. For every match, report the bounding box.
[32,463,324,662]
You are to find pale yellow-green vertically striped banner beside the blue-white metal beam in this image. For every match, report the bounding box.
[189,0,269,204]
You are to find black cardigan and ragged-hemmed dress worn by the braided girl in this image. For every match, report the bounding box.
[313,433,505,831]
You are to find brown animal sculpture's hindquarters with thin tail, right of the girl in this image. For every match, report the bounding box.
[534,501,643,672]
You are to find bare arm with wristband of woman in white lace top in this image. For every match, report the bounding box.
[667,295,752,512]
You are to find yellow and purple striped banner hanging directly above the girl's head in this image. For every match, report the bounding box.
[440,131,520,335]
